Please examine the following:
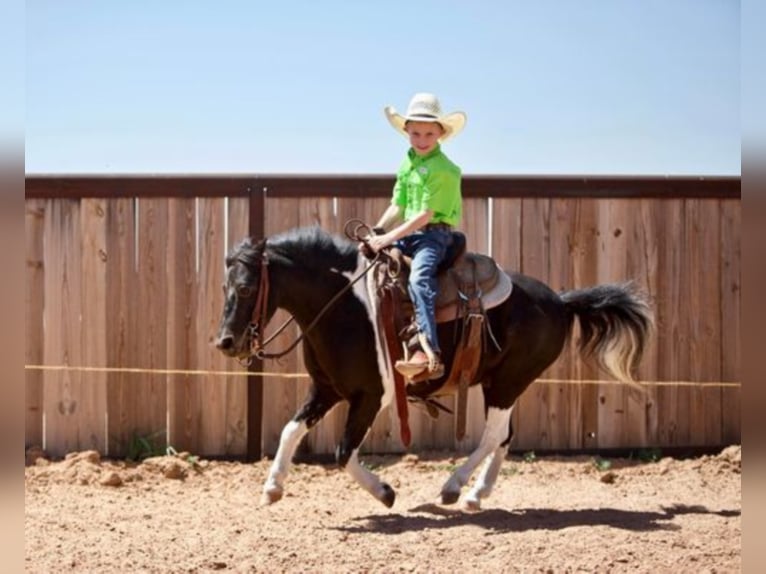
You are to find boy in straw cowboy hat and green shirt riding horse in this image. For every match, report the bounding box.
[368,93,466,378]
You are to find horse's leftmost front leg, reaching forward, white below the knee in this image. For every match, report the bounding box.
[261,384,340,504]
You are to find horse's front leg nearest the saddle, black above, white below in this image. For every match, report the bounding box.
[335,394,396,508]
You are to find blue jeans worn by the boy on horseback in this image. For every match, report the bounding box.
[394,228,452,353]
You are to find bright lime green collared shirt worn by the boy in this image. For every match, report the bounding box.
[391,145,462,226]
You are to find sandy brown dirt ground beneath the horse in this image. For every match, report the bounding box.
[24,446,742,573]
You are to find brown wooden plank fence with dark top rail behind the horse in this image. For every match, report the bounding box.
[26,176,741,458]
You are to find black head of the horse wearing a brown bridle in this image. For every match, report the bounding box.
[215,238,274,360]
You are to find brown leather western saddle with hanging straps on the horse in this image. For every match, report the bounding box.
[369,231,512,446]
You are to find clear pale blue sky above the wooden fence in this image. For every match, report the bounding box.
[24,0,741,176]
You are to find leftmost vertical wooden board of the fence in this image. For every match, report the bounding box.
[24,199,45,447]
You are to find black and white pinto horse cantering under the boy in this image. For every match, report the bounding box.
[216,227,652,510]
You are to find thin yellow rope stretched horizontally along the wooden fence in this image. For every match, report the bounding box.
[24,365,742,387]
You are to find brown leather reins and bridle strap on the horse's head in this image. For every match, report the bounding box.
[241,236,381,366]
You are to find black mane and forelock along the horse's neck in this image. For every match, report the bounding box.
[226,225,358,271]
